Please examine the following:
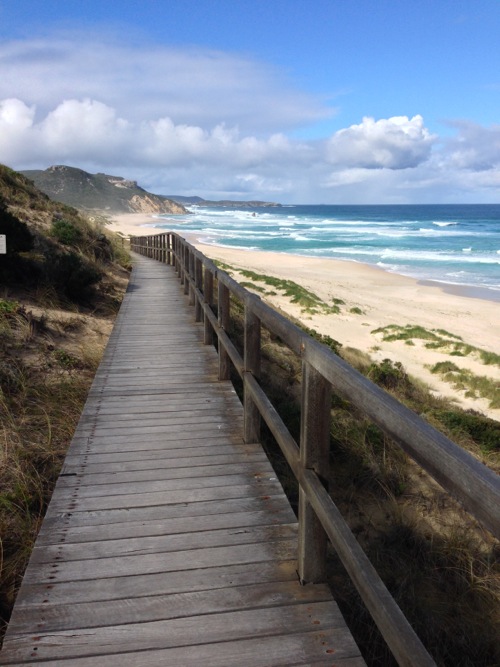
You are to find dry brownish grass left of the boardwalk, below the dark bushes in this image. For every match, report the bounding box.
[0,288,125,637]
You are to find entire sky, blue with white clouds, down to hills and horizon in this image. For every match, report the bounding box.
[0,0,500,203]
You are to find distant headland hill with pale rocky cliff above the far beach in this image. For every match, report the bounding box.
[21,165,187,214]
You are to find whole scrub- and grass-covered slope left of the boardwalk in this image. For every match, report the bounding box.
[0,165,130,644]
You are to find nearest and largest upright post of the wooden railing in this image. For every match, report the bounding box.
[298,361,331,584]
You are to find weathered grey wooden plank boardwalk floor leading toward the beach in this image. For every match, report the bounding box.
[0,256,364,667]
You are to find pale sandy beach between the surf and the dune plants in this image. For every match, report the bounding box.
[109,214,500,420]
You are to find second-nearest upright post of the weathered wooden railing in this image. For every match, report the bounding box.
[243,301,261,444]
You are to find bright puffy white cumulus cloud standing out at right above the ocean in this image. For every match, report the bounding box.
[327,115,435,169]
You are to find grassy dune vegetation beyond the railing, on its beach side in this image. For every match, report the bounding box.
[222,265,500,667]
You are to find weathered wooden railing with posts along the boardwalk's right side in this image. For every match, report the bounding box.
[131,233,500,667]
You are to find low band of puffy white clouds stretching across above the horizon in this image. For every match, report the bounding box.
[0,98,500,203]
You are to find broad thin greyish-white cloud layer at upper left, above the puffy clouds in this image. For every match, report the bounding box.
[0,33,333,133]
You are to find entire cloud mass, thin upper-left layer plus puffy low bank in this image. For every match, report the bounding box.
[0,33,500,203]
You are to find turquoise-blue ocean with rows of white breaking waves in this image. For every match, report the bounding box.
[153,204,500,300]
